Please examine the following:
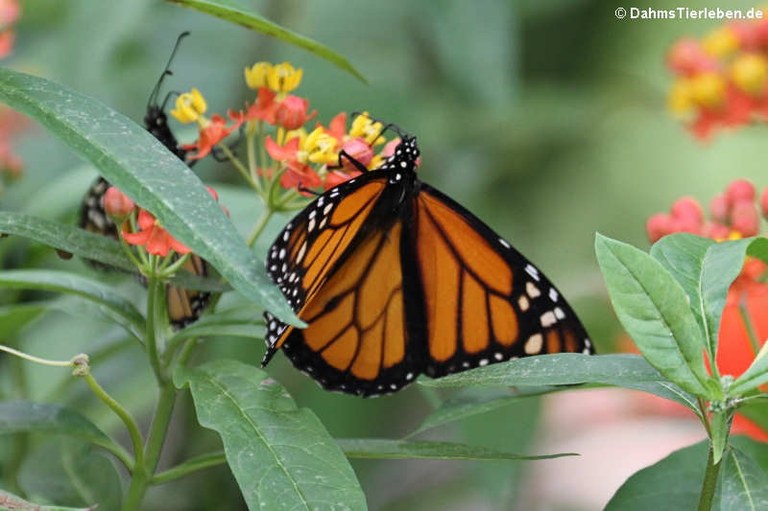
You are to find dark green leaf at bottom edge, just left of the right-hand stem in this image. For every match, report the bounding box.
[604,442,707,511]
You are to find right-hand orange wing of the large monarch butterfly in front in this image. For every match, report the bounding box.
[410,183,592,377]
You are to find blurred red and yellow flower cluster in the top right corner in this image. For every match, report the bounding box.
[667,12,768,140]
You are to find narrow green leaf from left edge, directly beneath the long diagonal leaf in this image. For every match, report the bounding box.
[0,211,136,271]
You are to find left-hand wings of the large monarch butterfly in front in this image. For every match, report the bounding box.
[263,172,426,395]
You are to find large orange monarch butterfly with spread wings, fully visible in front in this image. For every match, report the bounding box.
[262,135,593,396]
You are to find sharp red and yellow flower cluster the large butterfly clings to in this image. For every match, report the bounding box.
[171,62,396,202]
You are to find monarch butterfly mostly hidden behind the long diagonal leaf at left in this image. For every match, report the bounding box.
[78,32,211,328]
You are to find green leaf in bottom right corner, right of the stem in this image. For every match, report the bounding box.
[719,447,768,511]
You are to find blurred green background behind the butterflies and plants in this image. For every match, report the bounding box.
[0,0,768,510]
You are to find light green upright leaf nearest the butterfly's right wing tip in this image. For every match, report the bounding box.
[595,234,721,399]
